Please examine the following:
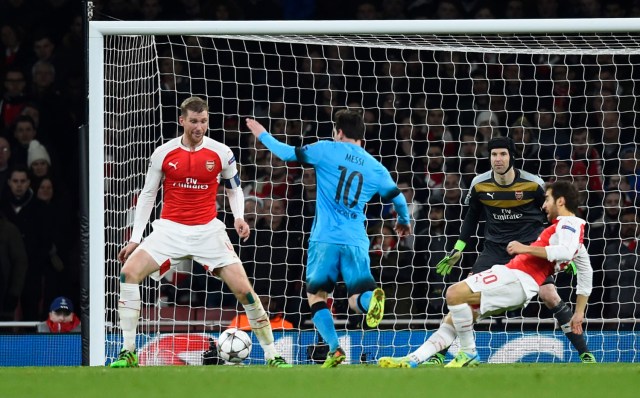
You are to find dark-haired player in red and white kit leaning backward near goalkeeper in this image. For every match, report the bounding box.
[446,181,593,368]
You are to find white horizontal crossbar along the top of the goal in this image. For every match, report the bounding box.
[89,18,640,37]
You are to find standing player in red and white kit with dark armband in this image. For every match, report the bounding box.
[110,97,291,368]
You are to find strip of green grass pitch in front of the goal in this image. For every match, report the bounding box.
[0,363,640,398]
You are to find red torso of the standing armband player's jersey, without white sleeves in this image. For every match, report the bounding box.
[161,147,222,225]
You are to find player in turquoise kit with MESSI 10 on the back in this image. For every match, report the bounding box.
[247,109,411,368]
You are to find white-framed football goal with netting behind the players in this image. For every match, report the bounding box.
[90,20,640,365]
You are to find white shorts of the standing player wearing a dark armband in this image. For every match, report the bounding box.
[136,218,240,280]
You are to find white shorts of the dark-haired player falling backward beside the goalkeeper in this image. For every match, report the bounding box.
[464,265,540,318]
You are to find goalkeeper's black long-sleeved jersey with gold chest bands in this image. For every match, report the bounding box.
[460,169,547,244]
